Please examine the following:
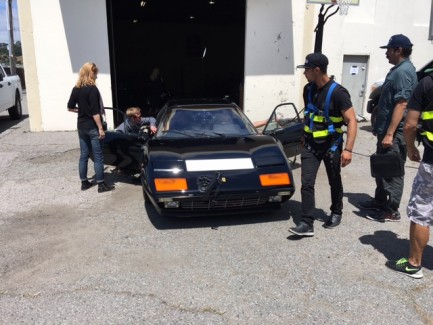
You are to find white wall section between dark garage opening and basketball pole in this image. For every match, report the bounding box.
[244,0,312,121]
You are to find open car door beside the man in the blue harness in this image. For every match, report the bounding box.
[262,103,304,158]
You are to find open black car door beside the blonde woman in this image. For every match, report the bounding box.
[103,107,148,172]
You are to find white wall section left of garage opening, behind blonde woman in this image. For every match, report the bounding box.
[18,0,112,131]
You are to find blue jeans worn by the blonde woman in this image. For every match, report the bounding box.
[78,129,104,183]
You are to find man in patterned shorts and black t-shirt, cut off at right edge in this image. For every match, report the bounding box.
[386,74,433,279]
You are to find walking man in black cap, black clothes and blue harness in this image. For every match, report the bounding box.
[289,53,357,236]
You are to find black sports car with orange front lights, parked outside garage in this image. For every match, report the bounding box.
[104,99,299,216]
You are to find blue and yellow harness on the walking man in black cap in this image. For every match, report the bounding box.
[304,81,344,154]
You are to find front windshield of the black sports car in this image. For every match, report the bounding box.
[156,107,256,138]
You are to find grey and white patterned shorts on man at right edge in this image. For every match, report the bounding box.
[407,162,433,226]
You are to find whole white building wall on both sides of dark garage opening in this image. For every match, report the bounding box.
[18,0,433,131]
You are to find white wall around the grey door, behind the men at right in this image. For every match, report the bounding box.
[307,0,433,112]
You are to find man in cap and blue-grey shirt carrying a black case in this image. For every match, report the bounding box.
[358,34,418,222]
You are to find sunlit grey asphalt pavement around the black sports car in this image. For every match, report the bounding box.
[0,97,433,324]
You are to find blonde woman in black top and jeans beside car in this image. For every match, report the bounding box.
[68,62,114,193]
